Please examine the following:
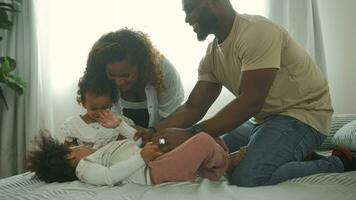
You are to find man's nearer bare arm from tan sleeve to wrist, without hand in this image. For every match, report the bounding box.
[202,69,278,137]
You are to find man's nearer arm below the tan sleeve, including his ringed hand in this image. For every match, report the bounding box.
[153,69,278,152]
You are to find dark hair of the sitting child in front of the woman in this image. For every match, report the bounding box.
[77,73,118,104]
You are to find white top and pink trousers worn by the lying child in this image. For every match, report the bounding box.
[76,133,229,186]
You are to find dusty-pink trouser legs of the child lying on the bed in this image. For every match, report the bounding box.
[148,133,229,184]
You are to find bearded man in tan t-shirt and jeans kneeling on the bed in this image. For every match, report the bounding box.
[142,0,350,186]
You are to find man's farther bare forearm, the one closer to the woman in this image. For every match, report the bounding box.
[155,81,222,131]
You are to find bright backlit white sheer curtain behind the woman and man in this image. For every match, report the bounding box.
[38,0,266,133]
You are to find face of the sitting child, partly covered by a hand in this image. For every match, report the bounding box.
[83,93,112,121]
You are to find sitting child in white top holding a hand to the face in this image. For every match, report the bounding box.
[58,74,140,149]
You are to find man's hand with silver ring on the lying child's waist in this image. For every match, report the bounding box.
[152,128,193,153]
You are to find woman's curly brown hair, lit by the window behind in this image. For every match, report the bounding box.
[85,28,166,94]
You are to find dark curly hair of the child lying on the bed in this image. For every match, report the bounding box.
[27,132,77,183]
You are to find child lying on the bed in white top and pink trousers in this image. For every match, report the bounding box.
[28,130,246,185]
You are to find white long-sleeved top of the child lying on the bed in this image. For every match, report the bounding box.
[76,139,151,186]
